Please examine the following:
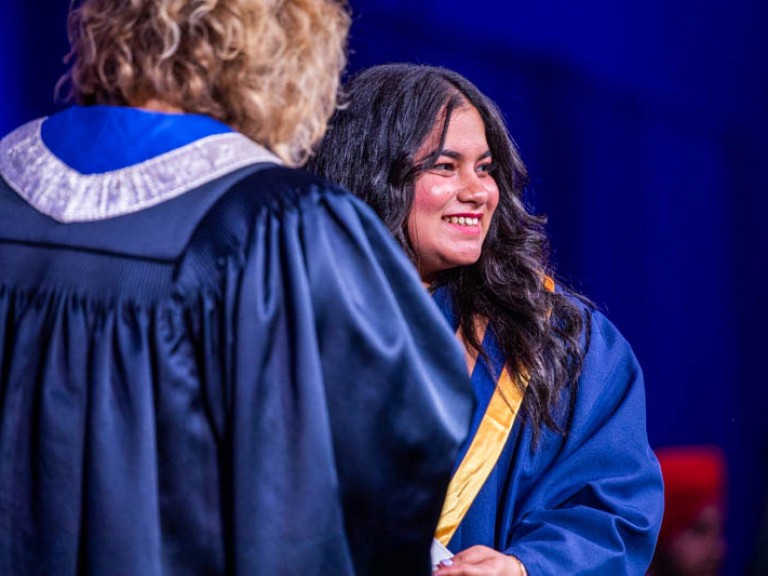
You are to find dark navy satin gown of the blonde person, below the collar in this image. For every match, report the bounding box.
[0,109,472,576]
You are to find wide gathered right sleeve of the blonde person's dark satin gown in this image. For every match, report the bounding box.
[187,170,473,575]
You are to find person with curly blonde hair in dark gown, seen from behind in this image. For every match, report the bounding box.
[0,0,472,576]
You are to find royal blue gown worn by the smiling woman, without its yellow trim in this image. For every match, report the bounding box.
[434,287,664,576]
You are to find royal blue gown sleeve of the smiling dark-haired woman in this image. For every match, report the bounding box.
[505,312,663,576]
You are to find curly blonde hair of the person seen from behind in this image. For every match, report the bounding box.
[59,0,350,166]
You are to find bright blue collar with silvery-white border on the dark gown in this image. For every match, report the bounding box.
[0,106,281,222]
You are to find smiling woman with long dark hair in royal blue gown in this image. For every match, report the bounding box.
[310,64,663,576]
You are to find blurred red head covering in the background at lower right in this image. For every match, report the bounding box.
[656,446,726,546]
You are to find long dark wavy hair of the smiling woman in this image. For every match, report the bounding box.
[307,64,585,436]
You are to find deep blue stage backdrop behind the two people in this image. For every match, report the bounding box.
[0,0,768,575]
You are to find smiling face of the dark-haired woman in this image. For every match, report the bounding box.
[408,104,499,282]
